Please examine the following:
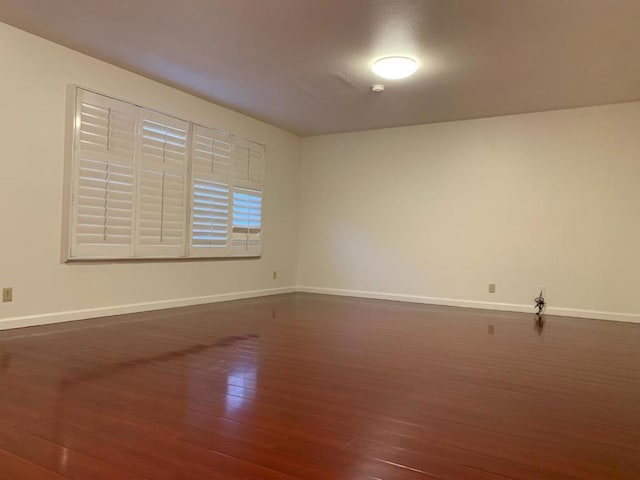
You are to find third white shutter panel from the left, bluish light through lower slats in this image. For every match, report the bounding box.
[190,125,233,257]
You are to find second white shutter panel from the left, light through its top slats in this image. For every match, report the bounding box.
[136,110,189,257]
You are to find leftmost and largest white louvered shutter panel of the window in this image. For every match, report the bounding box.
[70,89,136,258]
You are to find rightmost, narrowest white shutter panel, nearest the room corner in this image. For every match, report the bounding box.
[231,139,264,256]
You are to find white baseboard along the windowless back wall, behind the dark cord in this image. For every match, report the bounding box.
[297,286,640,323]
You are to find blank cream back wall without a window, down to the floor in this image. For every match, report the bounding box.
[298,103,640,321]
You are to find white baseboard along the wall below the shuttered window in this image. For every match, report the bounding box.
[0,287,296,330]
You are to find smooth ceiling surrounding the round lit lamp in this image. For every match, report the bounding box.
[0,0,640,136]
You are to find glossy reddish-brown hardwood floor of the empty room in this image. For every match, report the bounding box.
[0,294,640,480]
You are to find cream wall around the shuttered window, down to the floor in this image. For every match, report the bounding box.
[0,24,300,328]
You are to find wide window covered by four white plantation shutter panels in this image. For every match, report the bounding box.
[68,88,264,260]
